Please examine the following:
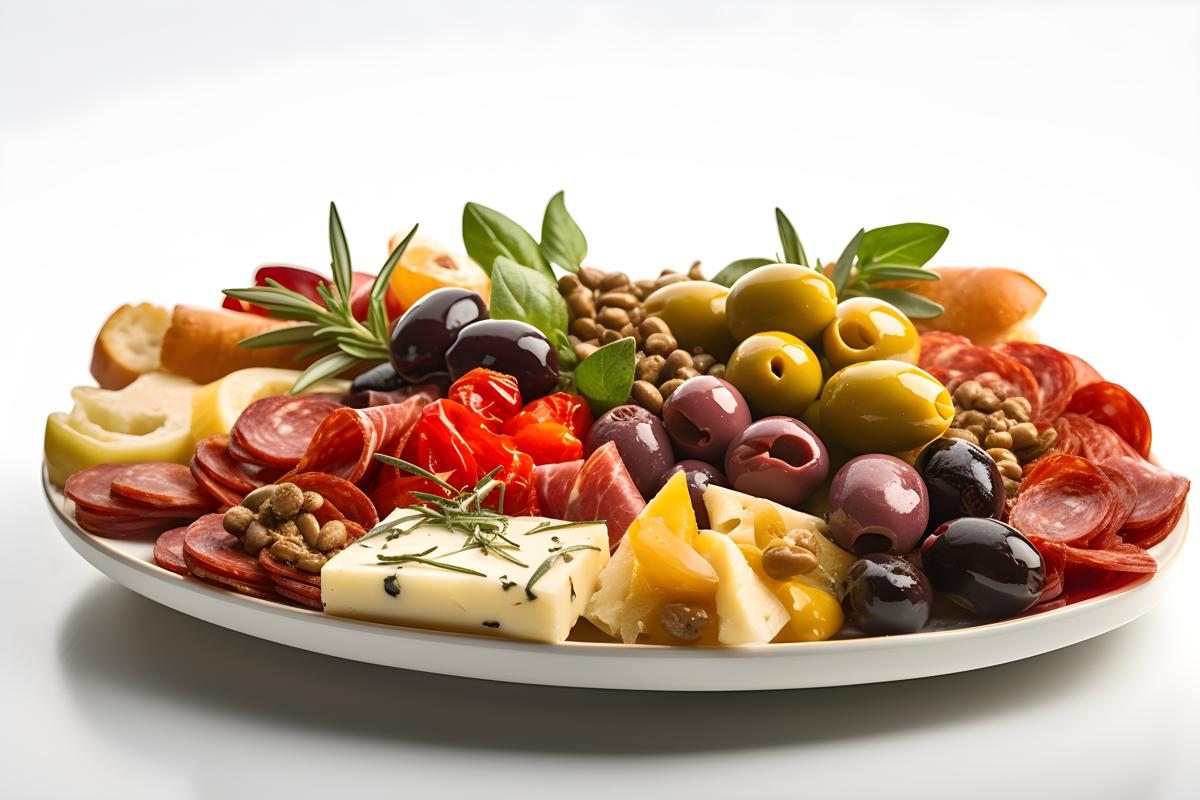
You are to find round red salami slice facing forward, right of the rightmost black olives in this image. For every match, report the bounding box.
[1008,453,1117,546]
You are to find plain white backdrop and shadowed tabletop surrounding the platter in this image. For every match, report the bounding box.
[0,0,1200,798]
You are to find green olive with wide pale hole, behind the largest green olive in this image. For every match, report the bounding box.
[821,297,920,369]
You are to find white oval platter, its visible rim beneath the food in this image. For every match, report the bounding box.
[43,475,1189,691]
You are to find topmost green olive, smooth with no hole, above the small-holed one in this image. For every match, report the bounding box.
[725,264,838,343]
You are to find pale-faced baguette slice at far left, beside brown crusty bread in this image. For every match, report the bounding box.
[91,302,170,389]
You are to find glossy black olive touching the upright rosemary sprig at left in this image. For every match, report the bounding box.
[391,287,487,383]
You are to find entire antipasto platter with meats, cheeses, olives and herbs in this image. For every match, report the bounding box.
[44,194,1190,690]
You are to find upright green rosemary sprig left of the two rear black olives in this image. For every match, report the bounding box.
[223,203,416,393]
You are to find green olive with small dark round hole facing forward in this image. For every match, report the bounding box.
[725,331,824,417]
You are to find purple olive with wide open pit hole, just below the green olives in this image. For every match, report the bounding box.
[725,416,829,507]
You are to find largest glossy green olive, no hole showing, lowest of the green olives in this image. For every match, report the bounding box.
[818,360,954,453]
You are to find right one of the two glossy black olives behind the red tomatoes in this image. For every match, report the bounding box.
[446,319,558,403]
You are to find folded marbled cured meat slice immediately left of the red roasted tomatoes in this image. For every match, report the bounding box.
[296,393,430,483]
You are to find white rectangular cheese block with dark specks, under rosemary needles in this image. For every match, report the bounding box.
[320,520,608,642]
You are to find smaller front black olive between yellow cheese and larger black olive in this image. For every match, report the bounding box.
[841,553,934,636]
